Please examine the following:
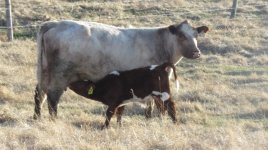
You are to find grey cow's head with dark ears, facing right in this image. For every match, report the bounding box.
[168,21,208,59]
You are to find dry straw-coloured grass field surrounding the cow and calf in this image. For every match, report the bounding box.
[0,0,268,150]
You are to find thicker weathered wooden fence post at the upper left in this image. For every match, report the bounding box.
[6,0,13,41]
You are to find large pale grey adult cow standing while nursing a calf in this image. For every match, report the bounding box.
[34,20,208,120]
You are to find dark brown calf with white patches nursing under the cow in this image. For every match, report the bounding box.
[69,63,177,127]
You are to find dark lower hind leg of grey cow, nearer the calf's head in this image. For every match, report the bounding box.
[47,88,64,120]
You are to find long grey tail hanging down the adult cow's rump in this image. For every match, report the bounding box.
[37,21,57,90]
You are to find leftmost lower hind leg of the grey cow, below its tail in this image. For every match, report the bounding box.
[33,84,46,119]
